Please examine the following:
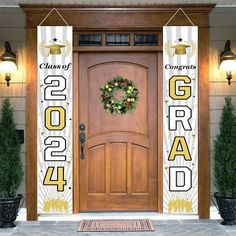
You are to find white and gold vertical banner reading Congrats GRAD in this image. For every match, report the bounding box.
[163,26,198,214]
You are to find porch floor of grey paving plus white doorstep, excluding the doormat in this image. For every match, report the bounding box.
[0,206,236,236]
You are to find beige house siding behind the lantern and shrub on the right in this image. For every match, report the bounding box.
[209,7,236,193]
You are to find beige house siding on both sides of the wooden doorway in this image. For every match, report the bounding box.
[0,7,236,208]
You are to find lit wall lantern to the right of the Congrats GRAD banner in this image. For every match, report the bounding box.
[220,40,236,85]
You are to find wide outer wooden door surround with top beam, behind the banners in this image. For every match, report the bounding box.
[20,4,215,220]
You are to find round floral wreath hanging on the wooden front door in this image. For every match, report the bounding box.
[100,75,139,114]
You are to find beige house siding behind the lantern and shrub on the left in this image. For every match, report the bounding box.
[0,8,27,203]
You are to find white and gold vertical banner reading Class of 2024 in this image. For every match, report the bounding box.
[37,26,73,214]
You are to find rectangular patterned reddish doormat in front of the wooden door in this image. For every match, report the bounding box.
[78,219,155,232]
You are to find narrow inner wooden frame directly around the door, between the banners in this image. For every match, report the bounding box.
[73,52,163,213]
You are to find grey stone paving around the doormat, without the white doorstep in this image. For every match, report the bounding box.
[0,220,236,236]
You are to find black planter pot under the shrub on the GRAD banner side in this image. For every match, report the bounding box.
[212,193,236,225]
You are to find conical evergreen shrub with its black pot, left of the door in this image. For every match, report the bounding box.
[0,98,24,228]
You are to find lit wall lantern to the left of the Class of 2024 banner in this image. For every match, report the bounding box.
[0,41,17,86]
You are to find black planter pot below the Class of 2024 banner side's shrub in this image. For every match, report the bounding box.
[0,194,24,228]
